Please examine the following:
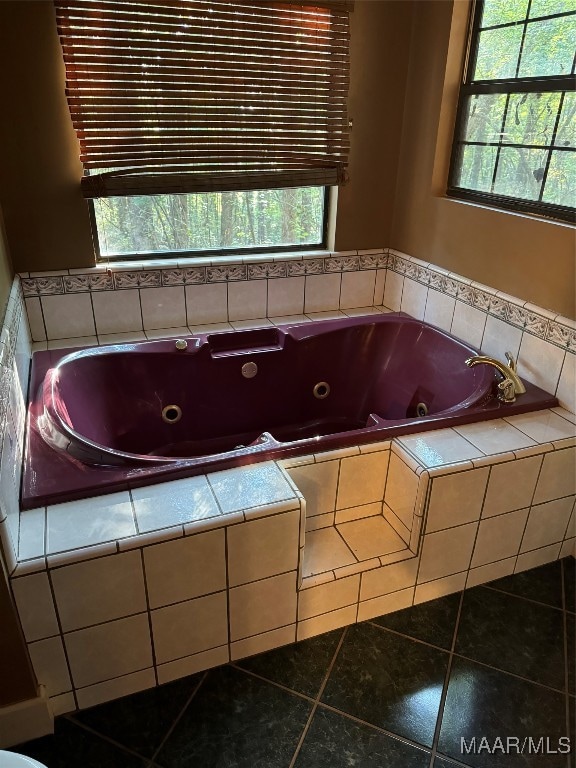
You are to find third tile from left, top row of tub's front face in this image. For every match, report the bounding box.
[143,530,226,608]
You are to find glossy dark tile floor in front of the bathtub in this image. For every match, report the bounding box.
[15,558,576,768]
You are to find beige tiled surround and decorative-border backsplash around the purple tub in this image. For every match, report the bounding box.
[0,251,576,736]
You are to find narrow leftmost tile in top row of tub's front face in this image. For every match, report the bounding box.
[11,571,60,642]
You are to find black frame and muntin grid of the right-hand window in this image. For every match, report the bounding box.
[446,0,576,224]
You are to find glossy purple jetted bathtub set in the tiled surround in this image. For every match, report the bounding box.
[22,313,557,508]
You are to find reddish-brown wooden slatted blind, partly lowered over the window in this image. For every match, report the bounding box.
[55,0,351,197]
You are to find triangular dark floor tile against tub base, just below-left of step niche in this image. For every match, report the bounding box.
[237,629,344,698]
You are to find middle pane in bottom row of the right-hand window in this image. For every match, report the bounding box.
[493,147,548,200]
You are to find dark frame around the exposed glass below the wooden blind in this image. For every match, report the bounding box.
[85,186,334,264]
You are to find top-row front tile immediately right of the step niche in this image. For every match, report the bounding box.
[426,467,489,533]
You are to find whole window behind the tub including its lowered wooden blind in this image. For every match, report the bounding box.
[55,0,350,258]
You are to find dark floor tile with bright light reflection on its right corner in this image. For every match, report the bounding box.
[322,623,448,747]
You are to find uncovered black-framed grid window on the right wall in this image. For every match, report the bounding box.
[448,0,576,221]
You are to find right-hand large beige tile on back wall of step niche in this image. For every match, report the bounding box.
[336,451,389,509]
